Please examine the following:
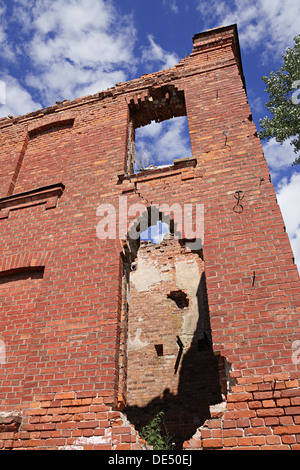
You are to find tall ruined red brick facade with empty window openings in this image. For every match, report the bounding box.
[0,26,300,449]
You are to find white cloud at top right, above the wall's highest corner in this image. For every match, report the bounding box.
[197,0,300,56]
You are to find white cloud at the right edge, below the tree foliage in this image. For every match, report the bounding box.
[277,173,300,273]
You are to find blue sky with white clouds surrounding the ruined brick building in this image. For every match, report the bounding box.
[0,0,300,270]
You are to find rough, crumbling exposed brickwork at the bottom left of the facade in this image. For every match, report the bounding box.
[0,392,151,450]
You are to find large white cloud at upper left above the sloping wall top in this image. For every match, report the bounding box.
[3,0,136,106]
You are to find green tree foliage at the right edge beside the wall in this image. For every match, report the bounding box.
[259,35,300,165]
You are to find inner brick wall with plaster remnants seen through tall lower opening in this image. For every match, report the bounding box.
[125,238,222,448]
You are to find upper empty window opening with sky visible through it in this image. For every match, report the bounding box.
[127,85,192,174]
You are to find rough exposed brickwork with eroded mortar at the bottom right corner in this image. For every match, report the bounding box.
[184,374,300,450]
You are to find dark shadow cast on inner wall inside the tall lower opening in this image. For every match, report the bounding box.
[124,273,222,449]
